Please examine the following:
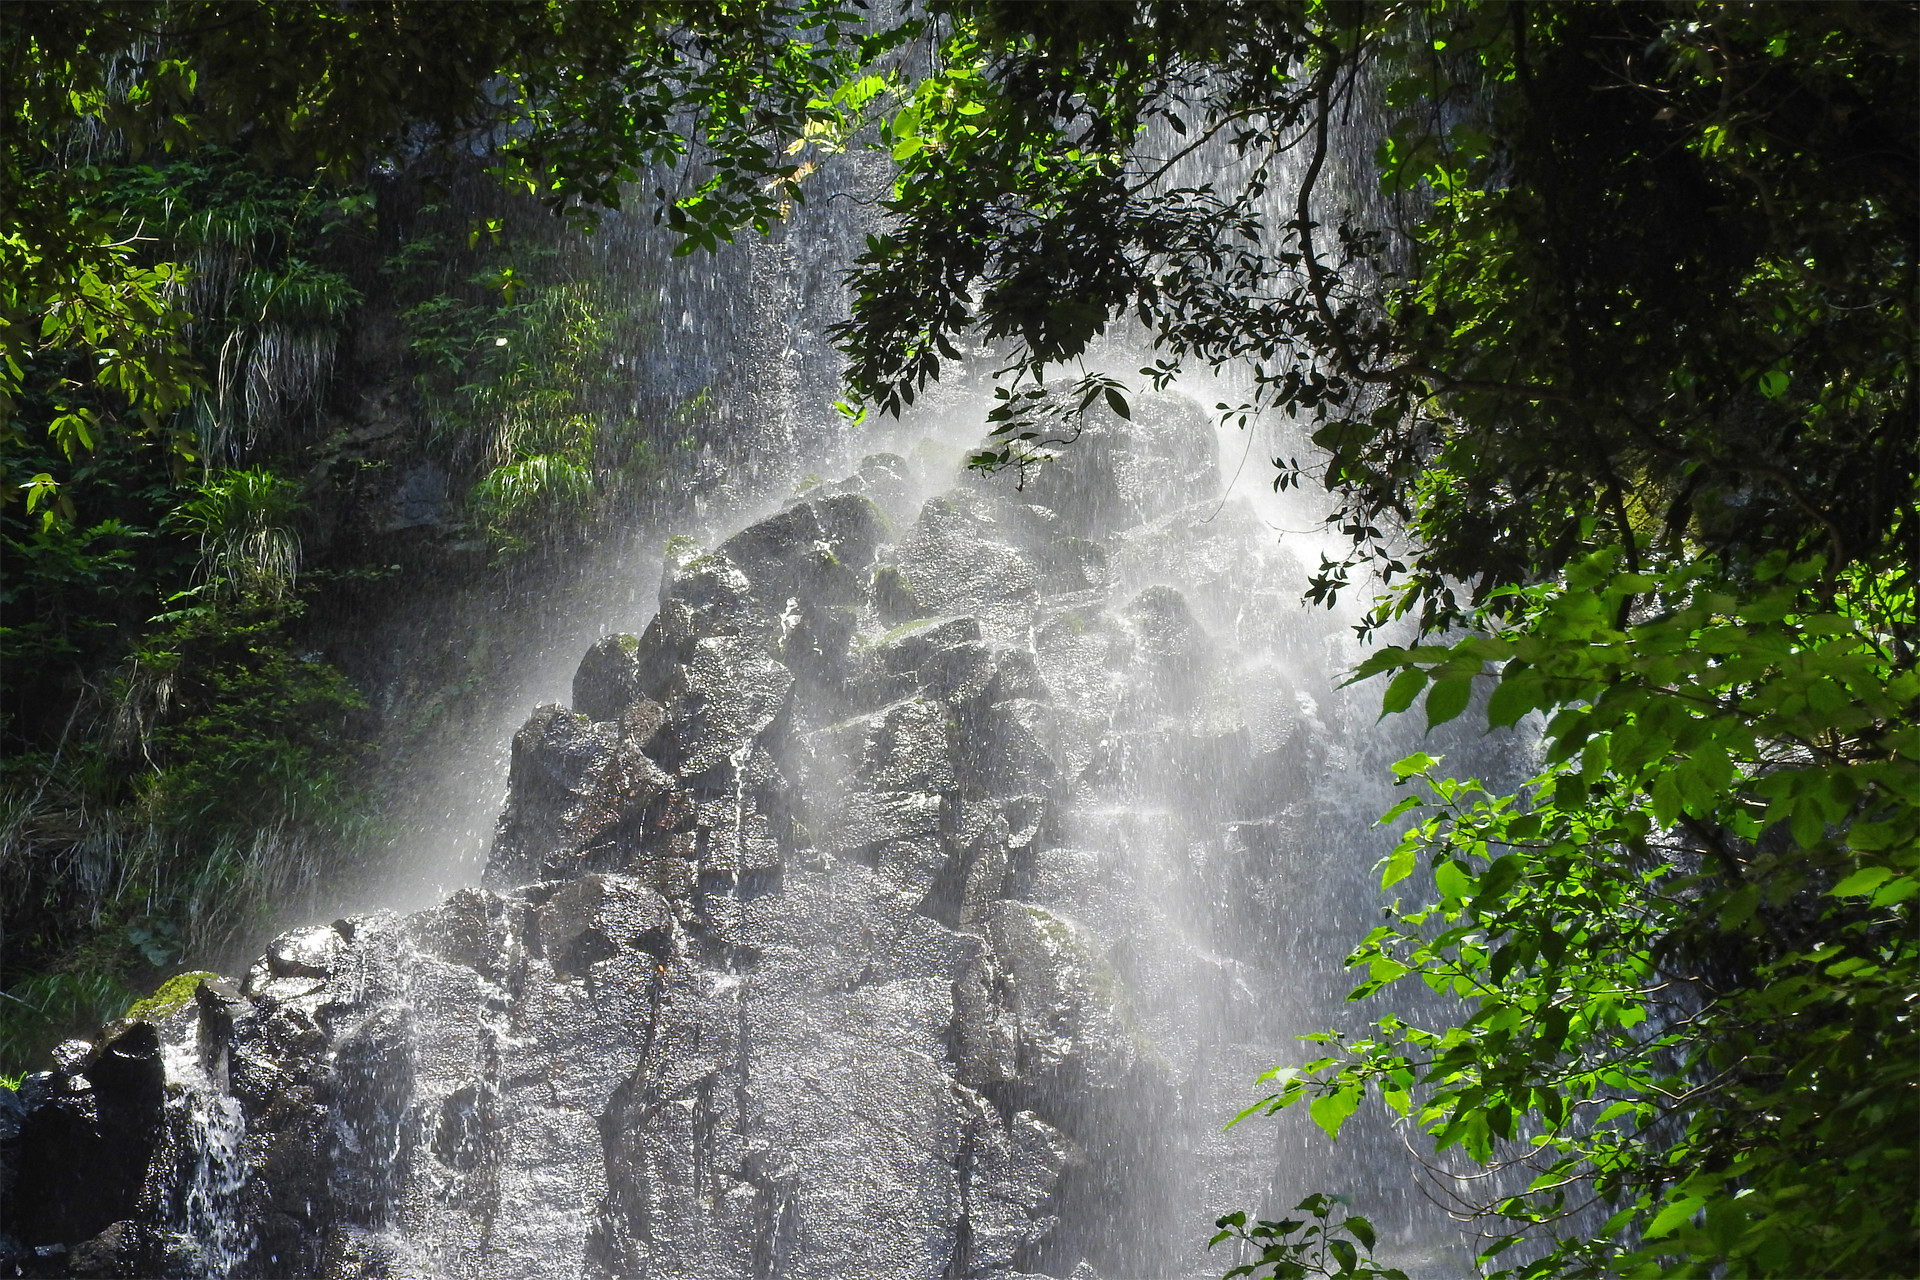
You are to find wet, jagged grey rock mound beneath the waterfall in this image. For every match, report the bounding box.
[0,401,1390,1280]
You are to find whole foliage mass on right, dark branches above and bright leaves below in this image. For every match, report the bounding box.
[817,2,1920,1276]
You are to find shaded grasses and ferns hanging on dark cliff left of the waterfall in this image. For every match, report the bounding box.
[0,148,668,1069]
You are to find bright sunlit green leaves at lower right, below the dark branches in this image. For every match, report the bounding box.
[1267,549,1920,1274]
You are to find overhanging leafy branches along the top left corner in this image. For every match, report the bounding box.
[0,0,899,516]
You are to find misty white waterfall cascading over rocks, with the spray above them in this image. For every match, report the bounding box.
[3,92,1517,1280]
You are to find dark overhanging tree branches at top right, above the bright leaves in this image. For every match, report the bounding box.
[841,4,1920,628]
